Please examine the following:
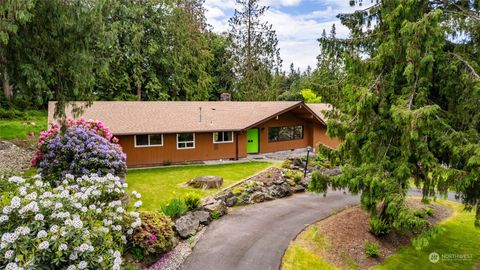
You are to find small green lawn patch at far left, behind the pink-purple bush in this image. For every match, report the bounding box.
[0,111,47,140]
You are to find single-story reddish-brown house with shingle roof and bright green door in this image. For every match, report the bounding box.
[48,101,339,167]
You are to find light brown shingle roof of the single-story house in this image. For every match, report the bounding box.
[48,101,332,135]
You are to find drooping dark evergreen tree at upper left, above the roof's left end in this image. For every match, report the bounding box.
[7,0,105,116]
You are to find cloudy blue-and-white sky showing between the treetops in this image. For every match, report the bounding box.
[205,0,370,70]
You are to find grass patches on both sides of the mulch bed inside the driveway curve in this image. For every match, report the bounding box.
[282,201,480,270]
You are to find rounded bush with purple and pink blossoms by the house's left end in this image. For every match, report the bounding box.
[32,118,126,185]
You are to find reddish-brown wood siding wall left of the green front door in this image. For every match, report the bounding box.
[118,132,246,167]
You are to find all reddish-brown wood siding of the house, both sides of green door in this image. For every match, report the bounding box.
[118,109,340,167]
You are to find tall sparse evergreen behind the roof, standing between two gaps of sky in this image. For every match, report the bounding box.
[229,0,281,100]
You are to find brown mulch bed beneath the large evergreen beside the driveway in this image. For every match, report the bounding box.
[316,198,452,269]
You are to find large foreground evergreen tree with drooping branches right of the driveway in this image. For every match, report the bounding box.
[321,0,480,231]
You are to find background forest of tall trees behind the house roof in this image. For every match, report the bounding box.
[0,0,334,112]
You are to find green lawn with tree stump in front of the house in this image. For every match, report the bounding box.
[126,162,272,210]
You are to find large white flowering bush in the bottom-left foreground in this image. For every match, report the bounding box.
[0,174,141,270]
